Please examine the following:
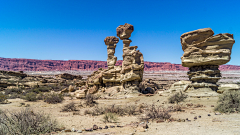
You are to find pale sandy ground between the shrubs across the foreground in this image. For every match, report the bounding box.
[0,95,240,135]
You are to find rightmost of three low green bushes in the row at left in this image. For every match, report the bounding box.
[43,93,64,104]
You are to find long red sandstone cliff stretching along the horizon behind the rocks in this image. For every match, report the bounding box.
[0,58,240,71]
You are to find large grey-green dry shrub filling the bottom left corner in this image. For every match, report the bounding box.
[0,109,58,135]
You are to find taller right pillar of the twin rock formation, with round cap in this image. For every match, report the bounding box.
[117,23,144,91]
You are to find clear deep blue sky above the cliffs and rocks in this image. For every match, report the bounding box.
[0,0,240,65]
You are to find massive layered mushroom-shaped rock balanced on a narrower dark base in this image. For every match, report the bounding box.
[180,28,235,93]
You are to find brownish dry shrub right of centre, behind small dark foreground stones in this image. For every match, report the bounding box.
[140,104,172,121]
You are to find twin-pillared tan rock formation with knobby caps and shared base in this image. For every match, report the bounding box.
[87,23,144,93]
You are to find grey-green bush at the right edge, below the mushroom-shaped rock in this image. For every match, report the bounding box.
[214,91,240,113]
